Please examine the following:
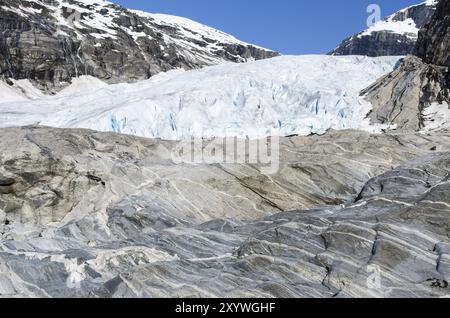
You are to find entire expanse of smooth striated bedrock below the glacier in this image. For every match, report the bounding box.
[0,127,450,297]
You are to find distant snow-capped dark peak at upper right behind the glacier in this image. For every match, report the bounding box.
[330,0,438,56]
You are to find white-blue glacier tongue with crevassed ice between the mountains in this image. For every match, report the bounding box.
[0,55,400,139]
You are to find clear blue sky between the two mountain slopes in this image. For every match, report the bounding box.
[112,0,423,54]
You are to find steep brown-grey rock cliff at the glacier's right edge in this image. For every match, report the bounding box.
[362,0,450,130]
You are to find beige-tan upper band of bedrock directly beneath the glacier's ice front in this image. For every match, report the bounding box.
[0,127,450,232]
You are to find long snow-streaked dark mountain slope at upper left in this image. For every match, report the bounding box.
[0,0,278,90]
